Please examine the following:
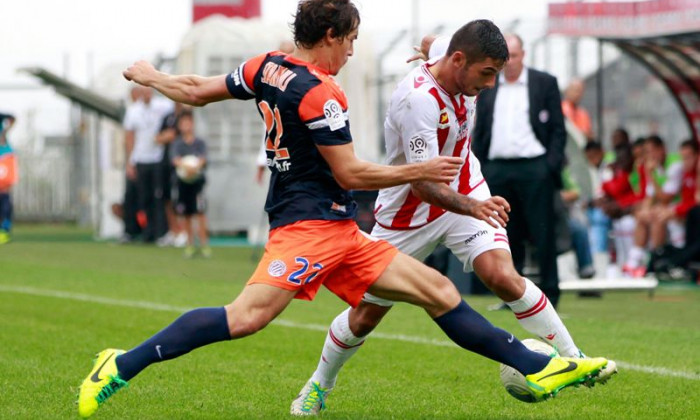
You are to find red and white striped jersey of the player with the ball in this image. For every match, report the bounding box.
[374,61,484,230]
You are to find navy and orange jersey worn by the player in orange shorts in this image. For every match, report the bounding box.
[226,52,357,229]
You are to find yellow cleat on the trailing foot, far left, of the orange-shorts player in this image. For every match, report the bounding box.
[78,349,129,418]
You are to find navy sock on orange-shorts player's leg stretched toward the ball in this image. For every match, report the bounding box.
[434,301,550,375]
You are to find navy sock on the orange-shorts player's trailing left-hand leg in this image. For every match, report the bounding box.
[116,307,231,381]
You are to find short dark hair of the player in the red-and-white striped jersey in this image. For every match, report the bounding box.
[447,19,509,63]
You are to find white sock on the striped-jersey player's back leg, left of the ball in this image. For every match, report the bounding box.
[311,308,366,389]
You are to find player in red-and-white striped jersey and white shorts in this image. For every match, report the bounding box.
[291,20,616,415]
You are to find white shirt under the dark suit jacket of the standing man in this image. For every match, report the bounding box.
[489,68,547,159]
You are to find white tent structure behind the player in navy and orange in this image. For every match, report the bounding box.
[176,16,379,232]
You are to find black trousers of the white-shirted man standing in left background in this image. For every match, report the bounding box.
[136,162,168,242]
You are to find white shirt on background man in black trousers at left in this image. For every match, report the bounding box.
[124,98,174,165]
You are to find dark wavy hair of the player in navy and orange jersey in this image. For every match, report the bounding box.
[292,0,360,49]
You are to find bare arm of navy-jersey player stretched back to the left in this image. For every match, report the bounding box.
[123,60,231,106]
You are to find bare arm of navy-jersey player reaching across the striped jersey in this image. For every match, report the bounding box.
[317,143,462,190]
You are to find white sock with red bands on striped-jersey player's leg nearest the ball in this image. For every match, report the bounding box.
[506,278,579,357]
